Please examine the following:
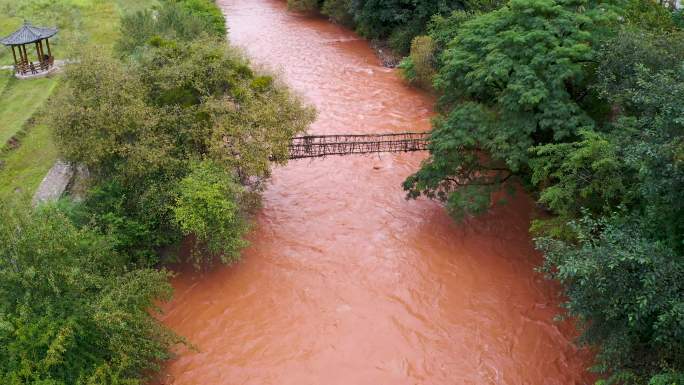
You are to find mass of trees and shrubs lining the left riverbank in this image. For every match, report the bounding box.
[0,0,314,385]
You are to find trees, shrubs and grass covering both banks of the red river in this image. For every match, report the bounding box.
[0,0,684,385]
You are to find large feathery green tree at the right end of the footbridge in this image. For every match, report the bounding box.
[404,0,598,216]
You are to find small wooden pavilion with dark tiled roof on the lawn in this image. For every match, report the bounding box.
[0,21,57,77]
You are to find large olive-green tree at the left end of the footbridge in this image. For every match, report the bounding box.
[52,38,313,264]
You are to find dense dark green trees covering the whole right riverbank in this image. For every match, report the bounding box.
[289,0,684,384]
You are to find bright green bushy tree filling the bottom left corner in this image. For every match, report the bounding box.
[0,202,180,385]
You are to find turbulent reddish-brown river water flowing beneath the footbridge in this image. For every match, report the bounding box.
[161,0,591,385]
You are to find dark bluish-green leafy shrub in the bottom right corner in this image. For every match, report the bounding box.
[536,218,684,384]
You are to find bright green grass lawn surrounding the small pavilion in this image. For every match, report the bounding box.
[0,0,157,199]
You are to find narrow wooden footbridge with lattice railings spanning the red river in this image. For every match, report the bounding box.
[289,132,430,159]
